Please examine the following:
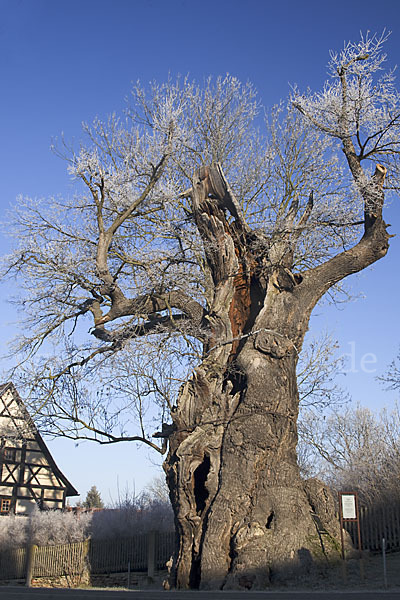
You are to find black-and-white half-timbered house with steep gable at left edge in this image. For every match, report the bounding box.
[0,383,78,515]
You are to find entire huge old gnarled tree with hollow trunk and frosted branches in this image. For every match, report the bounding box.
[5,37,400,588]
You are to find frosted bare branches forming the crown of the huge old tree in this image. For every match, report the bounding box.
[3,30,399,448]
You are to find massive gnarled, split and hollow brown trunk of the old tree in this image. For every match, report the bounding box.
[164,167,388,589]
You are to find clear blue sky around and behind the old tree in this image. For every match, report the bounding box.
[0,0,400,501]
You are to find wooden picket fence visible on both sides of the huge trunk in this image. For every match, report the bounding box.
[0,505,400,581]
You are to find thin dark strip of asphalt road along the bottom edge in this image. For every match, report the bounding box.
[0,587,400,600]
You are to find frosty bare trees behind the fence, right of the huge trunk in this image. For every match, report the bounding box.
[299,405,400,505]
